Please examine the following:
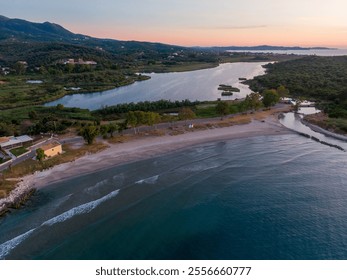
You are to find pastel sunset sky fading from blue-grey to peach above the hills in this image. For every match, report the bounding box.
[0,0,347,47]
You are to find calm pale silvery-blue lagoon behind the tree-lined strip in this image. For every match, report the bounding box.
[46,62,267,110]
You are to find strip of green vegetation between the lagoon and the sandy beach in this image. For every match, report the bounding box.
[0,93,272,136]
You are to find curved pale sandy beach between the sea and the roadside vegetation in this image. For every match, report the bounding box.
[0,116,293,216]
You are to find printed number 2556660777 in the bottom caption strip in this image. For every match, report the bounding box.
[188,266,252,276]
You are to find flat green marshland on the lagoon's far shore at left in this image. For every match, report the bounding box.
[0,70,147,110]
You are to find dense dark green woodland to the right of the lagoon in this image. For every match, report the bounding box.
[249,56,347,132]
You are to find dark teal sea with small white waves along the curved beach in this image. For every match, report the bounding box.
[0,134,347,260]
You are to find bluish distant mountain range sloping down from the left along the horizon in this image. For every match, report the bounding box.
[0,15,338,65]
